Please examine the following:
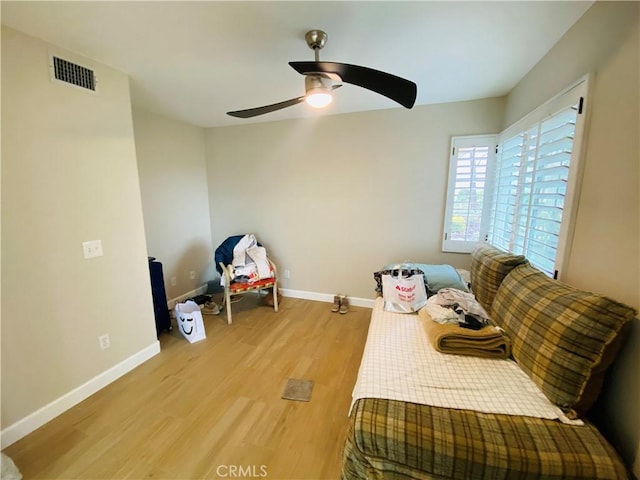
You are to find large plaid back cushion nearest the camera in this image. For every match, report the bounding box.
[491,264,637,414]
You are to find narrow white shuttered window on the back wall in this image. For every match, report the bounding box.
[442,135,496,252]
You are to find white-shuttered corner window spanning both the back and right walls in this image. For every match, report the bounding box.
[443,78,587,278]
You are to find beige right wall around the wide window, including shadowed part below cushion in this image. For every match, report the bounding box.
[505,2,640,476]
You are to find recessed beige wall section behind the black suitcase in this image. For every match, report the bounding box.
[133,109,213,299]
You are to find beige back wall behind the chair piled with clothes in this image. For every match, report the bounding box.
[206,99,503,299]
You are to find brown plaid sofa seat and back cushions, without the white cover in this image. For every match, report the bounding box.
[342,245,637,480]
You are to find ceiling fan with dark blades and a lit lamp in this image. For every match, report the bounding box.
[227,30,417,118]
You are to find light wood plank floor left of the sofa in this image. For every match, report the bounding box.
[5,295,371,480]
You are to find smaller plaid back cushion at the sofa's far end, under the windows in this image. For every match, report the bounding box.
[470,243,527,312]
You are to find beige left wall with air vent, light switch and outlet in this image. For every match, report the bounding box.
[2,27,157,429]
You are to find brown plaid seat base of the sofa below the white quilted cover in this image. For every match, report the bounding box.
[342,398,628,480]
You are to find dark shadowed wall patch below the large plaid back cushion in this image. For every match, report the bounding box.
[589,318,640,469]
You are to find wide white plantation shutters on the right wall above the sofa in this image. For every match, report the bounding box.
[488,81,586,277]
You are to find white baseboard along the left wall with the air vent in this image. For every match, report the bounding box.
[0,341,160,449]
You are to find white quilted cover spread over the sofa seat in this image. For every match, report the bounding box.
[351,297,582,424]
